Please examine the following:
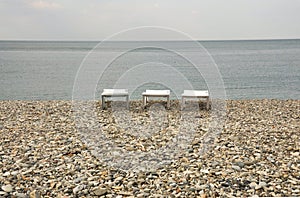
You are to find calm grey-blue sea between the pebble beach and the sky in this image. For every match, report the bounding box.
[0,39,300,100]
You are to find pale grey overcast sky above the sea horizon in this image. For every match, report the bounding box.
[0,0,300,40]
